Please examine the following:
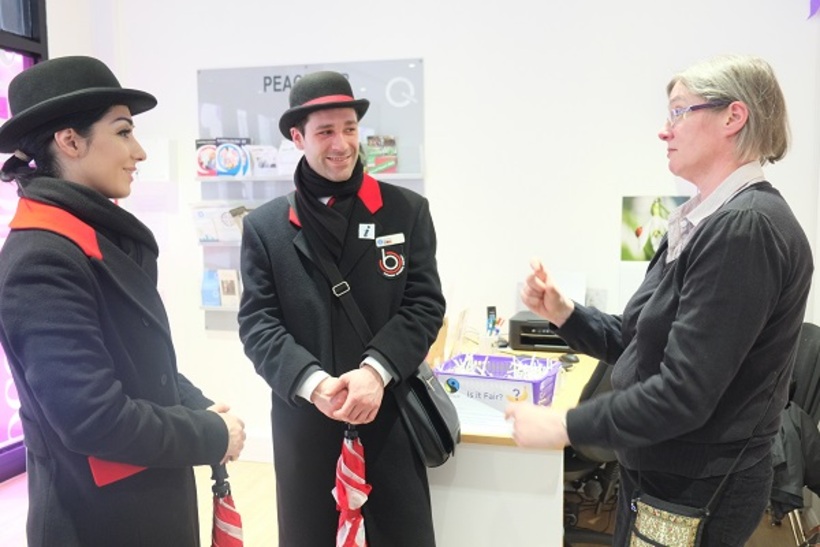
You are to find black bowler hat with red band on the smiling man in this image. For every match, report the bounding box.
[279,70,370,140]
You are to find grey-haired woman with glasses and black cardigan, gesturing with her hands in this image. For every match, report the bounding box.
[508,56,814,546]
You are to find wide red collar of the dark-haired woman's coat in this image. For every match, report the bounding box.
[9,198,102,260]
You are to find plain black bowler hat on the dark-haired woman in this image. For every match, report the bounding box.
[0,56,157,152]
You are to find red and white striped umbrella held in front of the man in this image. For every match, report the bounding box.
[333,425,372,547]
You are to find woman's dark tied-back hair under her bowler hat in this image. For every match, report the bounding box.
[0,106,111,187]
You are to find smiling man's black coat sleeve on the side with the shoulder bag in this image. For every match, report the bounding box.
[365,199,445,378]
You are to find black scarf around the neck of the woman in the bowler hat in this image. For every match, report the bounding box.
[18,177,159,281]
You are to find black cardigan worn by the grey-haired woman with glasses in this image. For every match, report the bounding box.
[559,182,814,478]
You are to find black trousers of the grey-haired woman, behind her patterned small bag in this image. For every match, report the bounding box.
[612,454,773,547]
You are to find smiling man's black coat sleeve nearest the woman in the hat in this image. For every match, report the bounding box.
[239,217,321,405]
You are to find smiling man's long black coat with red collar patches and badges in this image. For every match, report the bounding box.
[239,176,444,547]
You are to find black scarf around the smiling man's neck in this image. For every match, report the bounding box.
[293,156,364,263]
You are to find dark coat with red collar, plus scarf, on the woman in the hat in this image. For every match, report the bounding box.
[0,179,228,547]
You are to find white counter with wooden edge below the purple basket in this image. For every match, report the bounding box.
[428,397,564,547]
